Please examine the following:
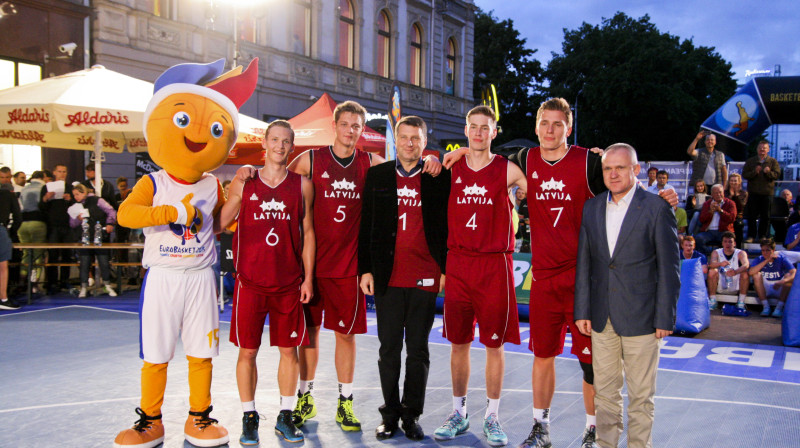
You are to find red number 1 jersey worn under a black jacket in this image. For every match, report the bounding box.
[389,171,442,292]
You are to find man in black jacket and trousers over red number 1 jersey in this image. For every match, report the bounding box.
[358,116,450,440]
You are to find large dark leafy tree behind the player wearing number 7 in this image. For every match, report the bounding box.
[546,12,736,160]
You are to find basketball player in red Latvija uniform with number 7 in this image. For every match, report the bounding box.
[444,98,677,448]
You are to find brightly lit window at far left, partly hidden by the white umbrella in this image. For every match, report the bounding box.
[0,59,42,177]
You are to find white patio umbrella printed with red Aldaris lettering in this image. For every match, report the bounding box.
[0,65,267,187]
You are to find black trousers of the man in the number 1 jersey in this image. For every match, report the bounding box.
[375,287,437,421]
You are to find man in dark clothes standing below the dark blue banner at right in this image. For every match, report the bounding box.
[742,140,781,242]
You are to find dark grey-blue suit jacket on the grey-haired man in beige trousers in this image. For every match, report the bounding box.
[574,188,680,336]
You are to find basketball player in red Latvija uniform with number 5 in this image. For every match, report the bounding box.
[289,101,441,431]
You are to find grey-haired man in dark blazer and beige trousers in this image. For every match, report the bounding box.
[574,143,680,448]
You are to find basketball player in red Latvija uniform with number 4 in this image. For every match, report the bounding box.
[434,106,527,446]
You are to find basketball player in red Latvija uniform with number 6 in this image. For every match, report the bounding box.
[221,120,315,445]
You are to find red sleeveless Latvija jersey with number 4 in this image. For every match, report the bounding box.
[447,155,514,253]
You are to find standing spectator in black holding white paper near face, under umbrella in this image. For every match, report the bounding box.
[39,165,76,294]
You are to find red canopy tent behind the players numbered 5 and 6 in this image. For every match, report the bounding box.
[226,93,386,165]
